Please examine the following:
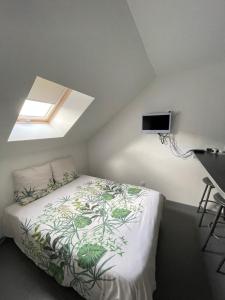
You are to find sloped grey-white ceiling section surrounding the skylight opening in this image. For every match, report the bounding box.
[0,0,154,155]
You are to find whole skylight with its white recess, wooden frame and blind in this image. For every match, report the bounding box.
[8,76,94,142]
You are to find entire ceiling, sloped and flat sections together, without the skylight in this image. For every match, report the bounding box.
[0,0,225,158]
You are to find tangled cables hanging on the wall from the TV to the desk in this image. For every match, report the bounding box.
[159,133,193,159]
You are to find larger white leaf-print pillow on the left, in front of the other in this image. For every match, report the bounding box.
[13,163,55,205]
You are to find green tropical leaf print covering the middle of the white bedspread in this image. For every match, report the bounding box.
[21,179,146,299]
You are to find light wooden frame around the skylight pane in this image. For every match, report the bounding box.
[16,89,72,124]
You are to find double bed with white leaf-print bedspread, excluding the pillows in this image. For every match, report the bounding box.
[3,175,163,300]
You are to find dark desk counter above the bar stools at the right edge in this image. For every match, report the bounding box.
[195,152,225,197]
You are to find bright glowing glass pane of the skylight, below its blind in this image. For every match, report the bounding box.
[19,99,53,119]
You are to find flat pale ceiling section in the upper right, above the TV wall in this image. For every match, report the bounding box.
[127,0,225,73]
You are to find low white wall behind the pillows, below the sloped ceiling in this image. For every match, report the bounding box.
[0,143,88,237]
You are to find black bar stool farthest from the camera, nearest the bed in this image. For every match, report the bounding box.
[197,177,215,227]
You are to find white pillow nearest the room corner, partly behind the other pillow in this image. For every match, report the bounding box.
[50,156,78,187]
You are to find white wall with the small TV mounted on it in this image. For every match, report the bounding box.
[88,62,225,205]
